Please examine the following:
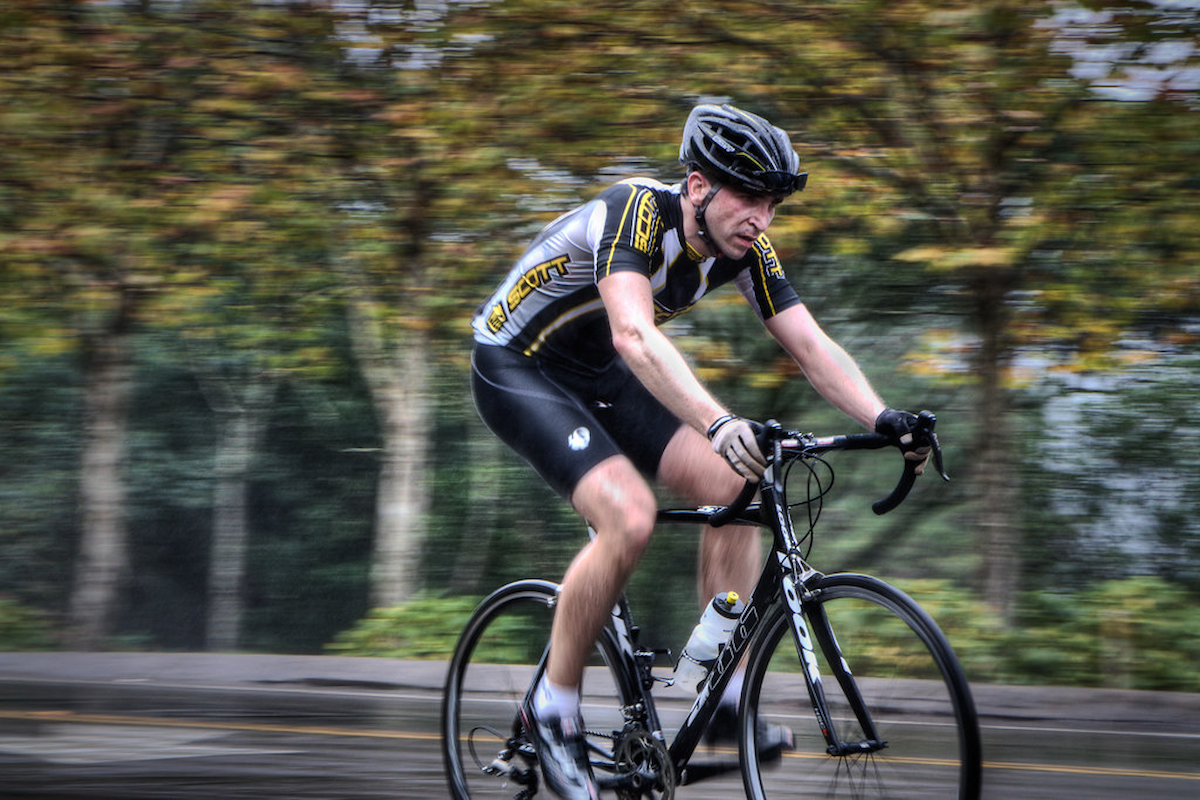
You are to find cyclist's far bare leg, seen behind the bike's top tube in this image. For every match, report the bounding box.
[659,427,762,604]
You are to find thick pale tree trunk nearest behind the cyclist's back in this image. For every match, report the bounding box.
[370,331,432,608]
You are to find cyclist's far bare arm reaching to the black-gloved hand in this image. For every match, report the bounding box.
[764,303,886,431]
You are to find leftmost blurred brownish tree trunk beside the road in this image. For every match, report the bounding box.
[67,293,133,650]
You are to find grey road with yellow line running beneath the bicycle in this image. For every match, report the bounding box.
[0,652,1200,800]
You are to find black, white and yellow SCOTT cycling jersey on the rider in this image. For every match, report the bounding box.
[472,178,799,371]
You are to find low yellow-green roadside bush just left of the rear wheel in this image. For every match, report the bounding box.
[325,594,479,660]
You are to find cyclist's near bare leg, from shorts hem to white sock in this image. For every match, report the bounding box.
[546,456,656,687]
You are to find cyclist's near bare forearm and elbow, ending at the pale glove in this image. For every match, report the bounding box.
[596,271,726,433]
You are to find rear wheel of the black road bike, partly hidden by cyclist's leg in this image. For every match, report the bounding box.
[442,581,631,800]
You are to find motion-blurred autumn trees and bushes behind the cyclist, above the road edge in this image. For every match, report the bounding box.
[0,0,1200,691]
